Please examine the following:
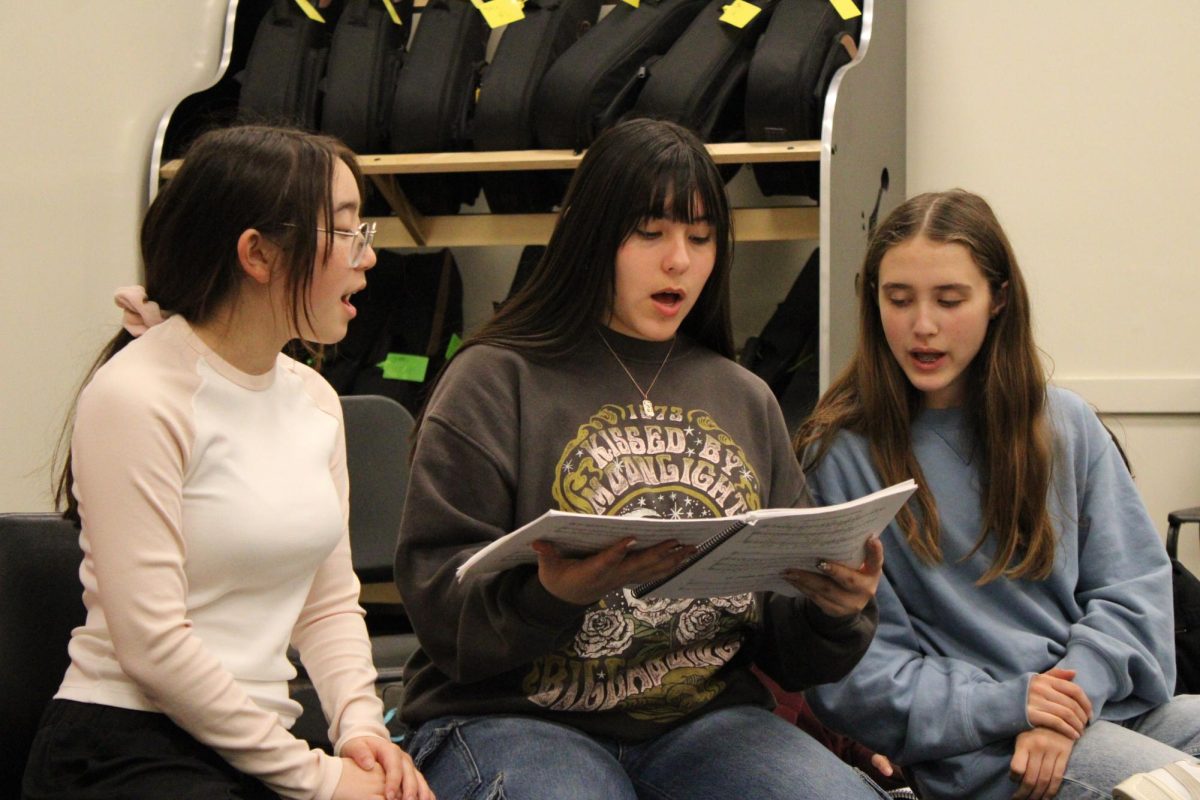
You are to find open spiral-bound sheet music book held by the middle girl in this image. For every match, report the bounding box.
[458,481,917,597]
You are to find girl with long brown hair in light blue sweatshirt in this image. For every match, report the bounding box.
[797,191,1200,800]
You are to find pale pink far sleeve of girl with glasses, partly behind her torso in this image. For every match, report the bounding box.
[292,392,389,753]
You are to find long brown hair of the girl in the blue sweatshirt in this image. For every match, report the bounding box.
[796,190,1055,584]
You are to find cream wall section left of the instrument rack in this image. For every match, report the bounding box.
[0,0,227,511]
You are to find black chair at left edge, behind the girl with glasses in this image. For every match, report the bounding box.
[0,513,84,798]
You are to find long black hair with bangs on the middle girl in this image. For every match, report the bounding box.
[463,119,734,357]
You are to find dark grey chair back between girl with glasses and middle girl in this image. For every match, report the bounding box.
[342,395,414,583]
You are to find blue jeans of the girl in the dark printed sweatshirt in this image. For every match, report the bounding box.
[408,705,887,800]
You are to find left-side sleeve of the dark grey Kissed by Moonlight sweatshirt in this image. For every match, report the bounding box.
[395,351,587,684]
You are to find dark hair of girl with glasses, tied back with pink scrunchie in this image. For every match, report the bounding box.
[54,126,362,521]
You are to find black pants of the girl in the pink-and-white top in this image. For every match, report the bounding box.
[22,700,278,800]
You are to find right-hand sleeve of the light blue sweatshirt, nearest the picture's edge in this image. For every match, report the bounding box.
[1058,398,1175,720]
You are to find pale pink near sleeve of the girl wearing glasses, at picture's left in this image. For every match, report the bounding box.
[72,371,341,799]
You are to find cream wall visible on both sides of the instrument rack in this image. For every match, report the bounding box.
[0,0,1200,573]
